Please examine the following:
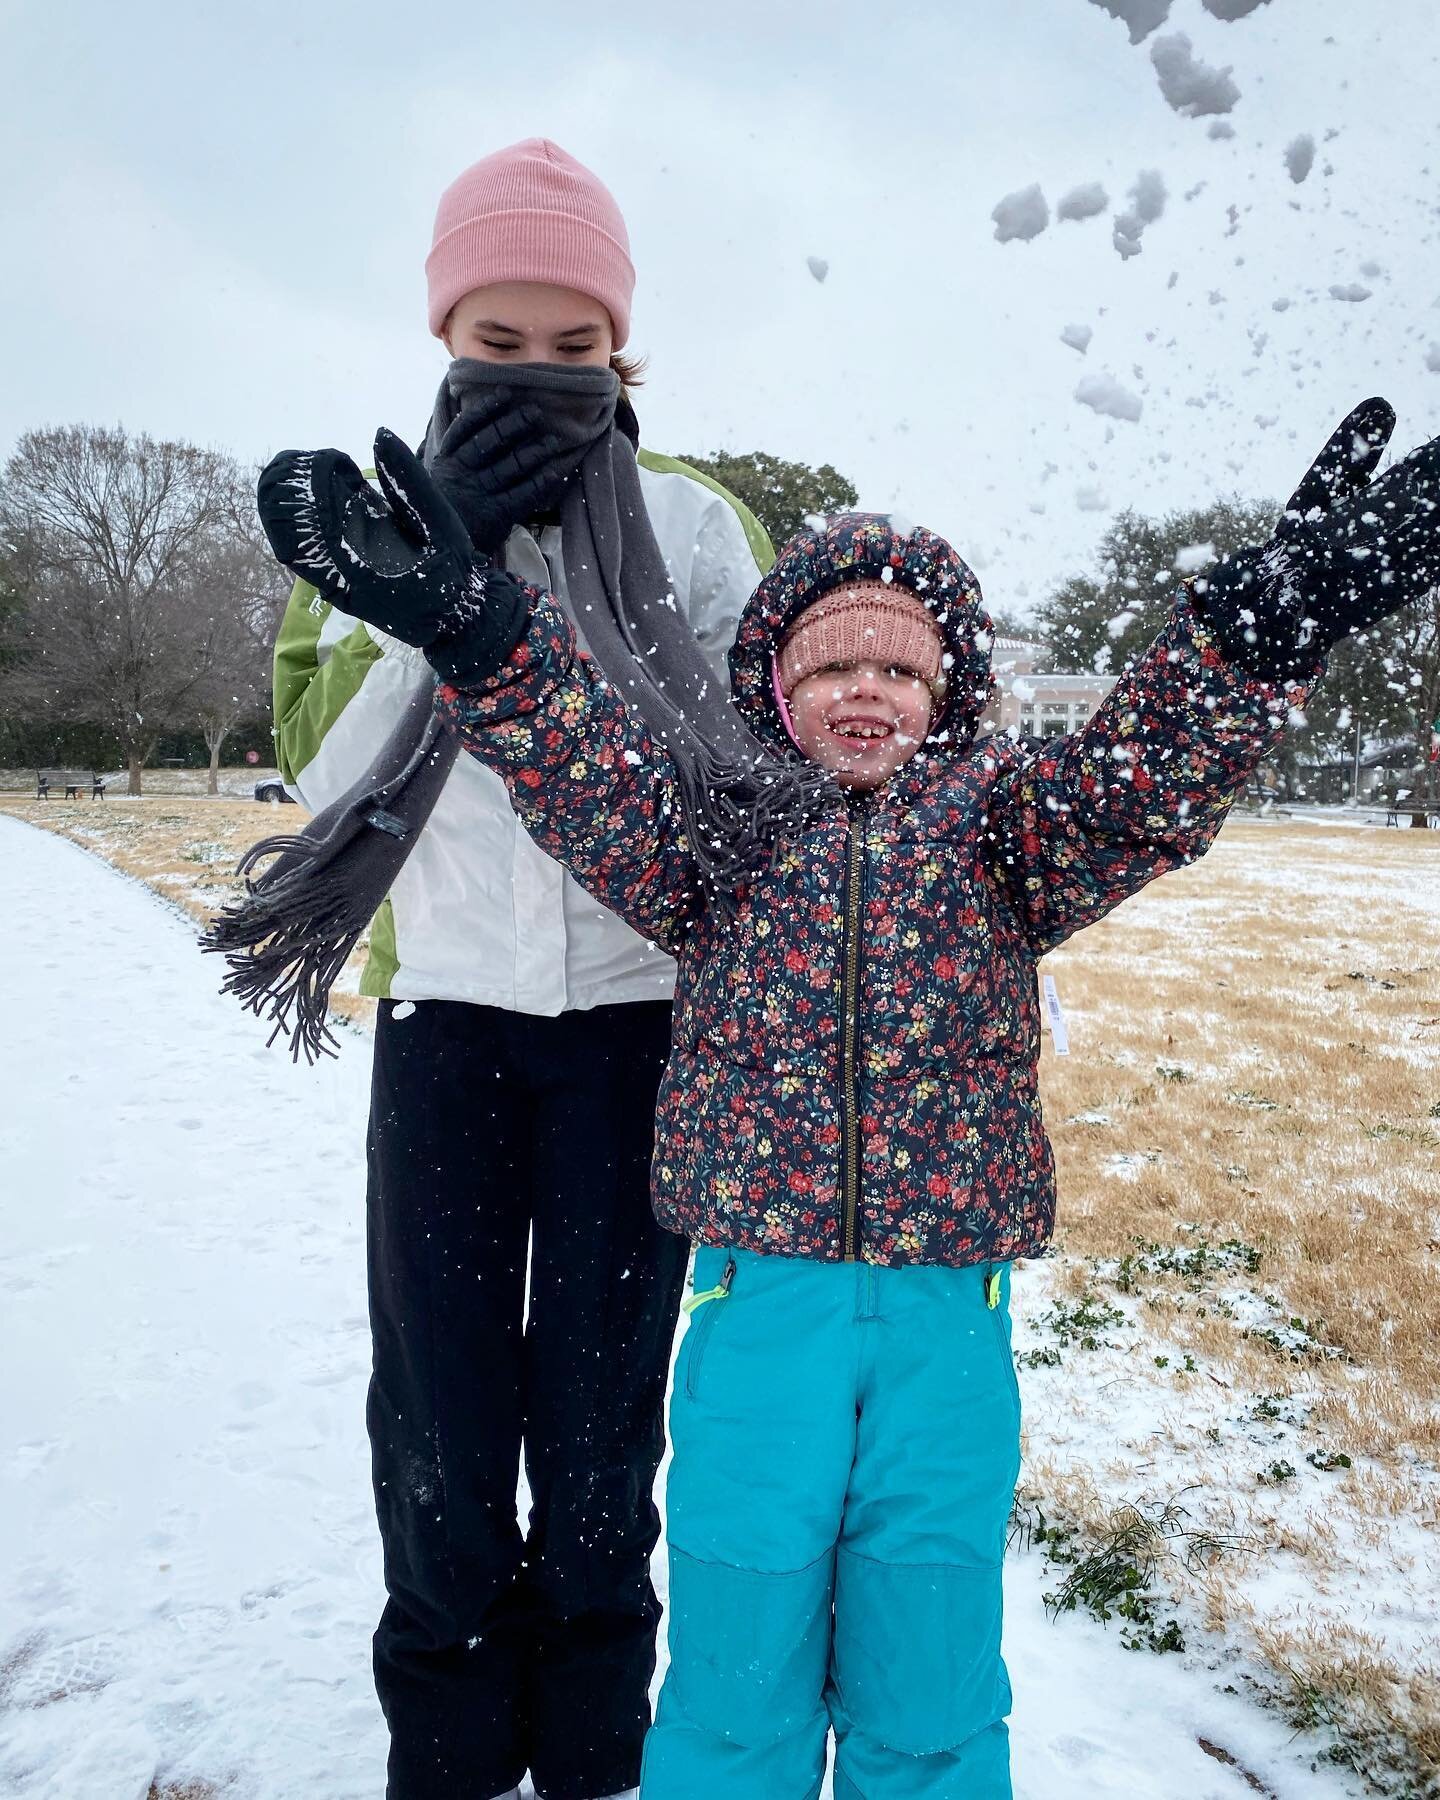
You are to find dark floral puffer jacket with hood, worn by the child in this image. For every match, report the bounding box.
[441,515,1305,1265]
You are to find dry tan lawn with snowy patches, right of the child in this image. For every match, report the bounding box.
[1021,823,1440,1795]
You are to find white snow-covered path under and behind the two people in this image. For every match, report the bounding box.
[0,819,1354,1800]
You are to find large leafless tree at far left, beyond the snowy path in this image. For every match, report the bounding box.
[0,425,271,794]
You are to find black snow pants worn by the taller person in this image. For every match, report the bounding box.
[367,1001,688,1800]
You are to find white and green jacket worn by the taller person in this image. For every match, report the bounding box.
[266,450,774,1015]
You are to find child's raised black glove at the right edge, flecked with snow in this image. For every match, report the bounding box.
[1197,400,1440,682]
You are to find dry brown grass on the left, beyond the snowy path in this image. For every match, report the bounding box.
[0,788,374,1022]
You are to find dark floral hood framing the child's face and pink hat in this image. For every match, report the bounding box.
[729,513,995,754]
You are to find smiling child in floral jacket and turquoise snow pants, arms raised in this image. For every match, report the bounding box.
[266,403,1440,1800]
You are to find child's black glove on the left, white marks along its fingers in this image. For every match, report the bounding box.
[256,427,529,688]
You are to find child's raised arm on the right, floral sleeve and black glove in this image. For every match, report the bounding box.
[990,400,1440,950]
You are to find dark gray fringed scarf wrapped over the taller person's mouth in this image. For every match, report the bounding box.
[202,358,833,1062]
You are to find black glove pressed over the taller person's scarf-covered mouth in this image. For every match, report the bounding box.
[428,387,576,553]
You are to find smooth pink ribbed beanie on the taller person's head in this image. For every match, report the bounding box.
[425,137,635,349]
